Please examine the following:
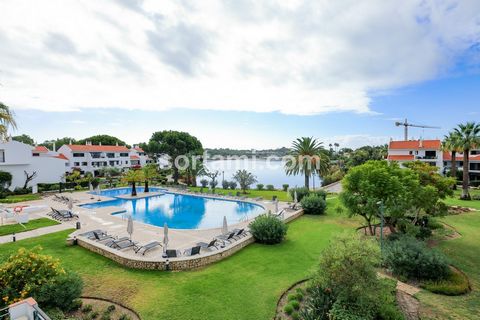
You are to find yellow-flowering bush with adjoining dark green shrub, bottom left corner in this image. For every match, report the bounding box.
[0,247,83,311]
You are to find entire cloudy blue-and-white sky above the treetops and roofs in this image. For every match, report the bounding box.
[0,0,480,149]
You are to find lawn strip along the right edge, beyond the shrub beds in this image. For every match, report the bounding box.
[418,212,480,319]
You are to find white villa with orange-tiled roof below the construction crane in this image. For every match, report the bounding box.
[387,139,480,181]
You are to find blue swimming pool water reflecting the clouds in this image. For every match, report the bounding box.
[82,188,265,229]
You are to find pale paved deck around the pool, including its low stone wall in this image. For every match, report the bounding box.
[1,190,301,270]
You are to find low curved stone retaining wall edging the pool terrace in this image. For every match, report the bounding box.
[71,210,303,271]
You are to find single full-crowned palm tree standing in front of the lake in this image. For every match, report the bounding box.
[285,137,330,188]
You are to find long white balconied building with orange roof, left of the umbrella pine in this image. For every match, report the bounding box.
[58,143,150,175]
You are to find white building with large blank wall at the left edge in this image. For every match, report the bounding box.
[0,139,67,190]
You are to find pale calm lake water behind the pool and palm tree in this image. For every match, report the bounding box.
[197,159,320,189]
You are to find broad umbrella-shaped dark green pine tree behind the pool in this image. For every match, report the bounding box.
[148,131,203,183]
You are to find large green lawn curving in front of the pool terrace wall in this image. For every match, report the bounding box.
[0,199,356,320]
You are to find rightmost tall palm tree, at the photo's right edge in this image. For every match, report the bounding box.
[454,122,480,200]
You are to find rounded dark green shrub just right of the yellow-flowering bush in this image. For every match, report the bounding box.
[35,272,83,311]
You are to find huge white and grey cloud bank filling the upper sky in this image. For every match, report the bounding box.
[0,0,480,114]
